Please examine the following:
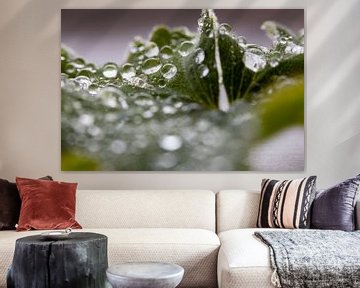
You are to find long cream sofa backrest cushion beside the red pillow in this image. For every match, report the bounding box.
[76,190,215,231]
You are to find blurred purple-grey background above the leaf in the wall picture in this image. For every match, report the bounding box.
[61,9,304,65]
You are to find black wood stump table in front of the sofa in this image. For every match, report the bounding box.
[7,232,108,288]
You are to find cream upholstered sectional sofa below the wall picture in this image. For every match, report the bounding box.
[0,190,360,288]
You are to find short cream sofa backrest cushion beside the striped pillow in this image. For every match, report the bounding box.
[216,190,260,233]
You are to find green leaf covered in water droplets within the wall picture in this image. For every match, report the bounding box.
[61,9,304,171]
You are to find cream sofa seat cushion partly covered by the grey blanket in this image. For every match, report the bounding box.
[217,228,279,288]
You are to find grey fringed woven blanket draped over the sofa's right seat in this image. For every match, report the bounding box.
[255,230,360,288]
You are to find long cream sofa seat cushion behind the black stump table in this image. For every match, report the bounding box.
[0,228,220,288]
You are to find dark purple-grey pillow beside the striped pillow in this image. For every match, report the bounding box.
[311,175,360,231]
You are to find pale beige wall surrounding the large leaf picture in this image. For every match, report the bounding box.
[0,0,360,190]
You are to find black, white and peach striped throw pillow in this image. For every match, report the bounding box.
[257,176,316,229]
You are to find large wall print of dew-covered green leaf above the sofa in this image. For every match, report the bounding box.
[61,9,305,171]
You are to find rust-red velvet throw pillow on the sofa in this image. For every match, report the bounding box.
[16,177,81,231]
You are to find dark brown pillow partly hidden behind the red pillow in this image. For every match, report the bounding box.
[0,176,52,230]
